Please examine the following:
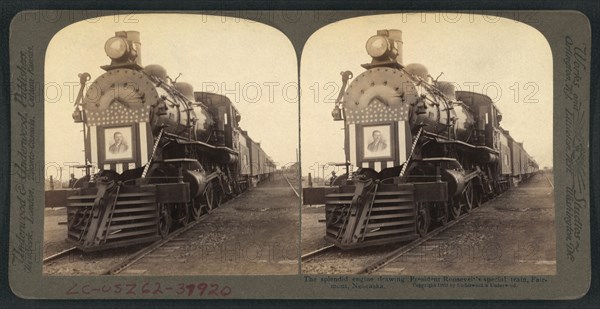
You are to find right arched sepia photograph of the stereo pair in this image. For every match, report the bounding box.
[300,12,556,274]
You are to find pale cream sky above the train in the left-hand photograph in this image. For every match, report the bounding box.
[45,14,298,180]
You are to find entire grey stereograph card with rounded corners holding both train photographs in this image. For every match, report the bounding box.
[0,10,592,299]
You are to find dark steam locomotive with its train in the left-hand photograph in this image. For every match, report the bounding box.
[61,31,276,251]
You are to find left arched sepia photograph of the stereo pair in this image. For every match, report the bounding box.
[43,14,300,276]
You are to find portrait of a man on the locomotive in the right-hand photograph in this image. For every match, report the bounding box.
[362,125,394,160]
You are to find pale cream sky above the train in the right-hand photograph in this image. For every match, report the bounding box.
[300,13,553,177]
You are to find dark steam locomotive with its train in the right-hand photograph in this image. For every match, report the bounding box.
[303,30,538,249]
